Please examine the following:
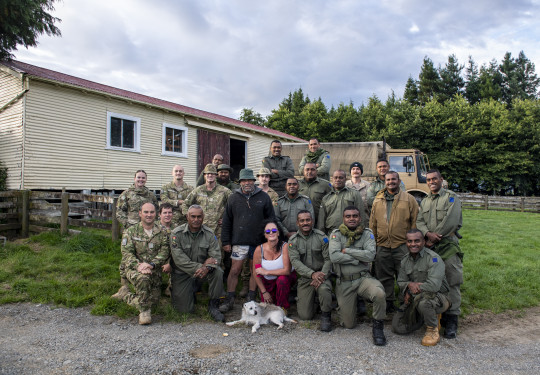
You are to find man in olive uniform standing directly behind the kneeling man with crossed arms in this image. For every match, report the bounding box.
[317,169,368,233]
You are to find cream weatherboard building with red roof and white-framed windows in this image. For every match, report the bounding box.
[0,61,305,191]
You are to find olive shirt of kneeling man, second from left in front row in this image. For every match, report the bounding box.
[171,224,221,276]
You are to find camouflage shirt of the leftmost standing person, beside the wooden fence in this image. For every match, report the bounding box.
[116,185,158,230]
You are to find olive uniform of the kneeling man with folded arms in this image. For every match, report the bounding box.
[328,228,386,328]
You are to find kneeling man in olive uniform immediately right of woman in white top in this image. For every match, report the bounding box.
[289,210,332,332]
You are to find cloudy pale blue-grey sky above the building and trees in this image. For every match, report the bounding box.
[14,0,540,118]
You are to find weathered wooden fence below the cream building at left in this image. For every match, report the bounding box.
[0,190,120,240]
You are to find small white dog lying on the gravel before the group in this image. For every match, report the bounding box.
[226,301,298,333]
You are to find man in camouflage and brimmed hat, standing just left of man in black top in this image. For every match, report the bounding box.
[182,164,232,238]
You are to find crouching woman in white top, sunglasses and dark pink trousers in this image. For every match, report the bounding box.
[252,219,296,309]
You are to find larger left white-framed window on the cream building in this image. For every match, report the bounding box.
[107,112,141,152]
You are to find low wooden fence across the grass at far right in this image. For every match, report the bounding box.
[458,193,540,212]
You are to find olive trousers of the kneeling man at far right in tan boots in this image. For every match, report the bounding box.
[392,292,450,335]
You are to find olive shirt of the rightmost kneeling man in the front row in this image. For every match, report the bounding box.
[397,247,449,295]
